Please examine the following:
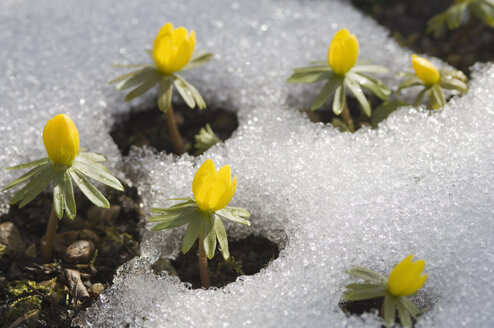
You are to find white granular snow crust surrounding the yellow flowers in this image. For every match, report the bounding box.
[0,0,494,327]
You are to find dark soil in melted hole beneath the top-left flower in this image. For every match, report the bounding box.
[110,104,238,156]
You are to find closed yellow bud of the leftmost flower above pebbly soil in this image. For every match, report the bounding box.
[43,114,79,165]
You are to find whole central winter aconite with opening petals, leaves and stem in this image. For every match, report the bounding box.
[149,159,250,288]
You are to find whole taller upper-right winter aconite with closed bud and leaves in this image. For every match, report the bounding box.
[286,29,391,132]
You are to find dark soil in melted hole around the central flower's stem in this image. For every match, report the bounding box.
[172,235,280,289]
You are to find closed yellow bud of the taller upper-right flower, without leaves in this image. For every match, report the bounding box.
[328,28,358,75]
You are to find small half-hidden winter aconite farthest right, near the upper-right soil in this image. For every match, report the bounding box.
[398,54,468,109]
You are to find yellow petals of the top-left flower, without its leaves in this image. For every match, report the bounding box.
[153,23,196,74]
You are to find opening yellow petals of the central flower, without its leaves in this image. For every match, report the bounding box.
[192,159,237,213]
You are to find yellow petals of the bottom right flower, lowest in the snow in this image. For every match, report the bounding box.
[388,254,427,296]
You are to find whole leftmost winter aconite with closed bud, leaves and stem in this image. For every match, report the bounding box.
[2,114,123,262]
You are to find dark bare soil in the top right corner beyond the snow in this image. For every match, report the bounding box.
[352,0,494,75]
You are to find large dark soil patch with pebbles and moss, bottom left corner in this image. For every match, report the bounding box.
[0,187,142,328]
